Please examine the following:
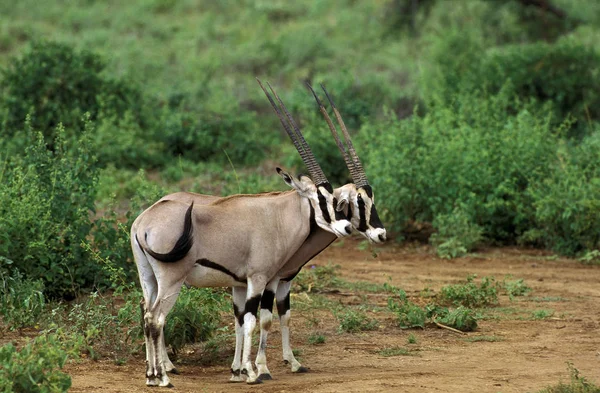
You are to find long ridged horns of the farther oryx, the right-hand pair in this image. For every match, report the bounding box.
[306,82,369,188]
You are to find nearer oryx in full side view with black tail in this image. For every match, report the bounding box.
[131,81,351,386]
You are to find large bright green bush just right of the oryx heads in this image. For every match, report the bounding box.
[359,87,557,242]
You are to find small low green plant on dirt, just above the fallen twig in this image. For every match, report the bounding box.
[437,275,498,307]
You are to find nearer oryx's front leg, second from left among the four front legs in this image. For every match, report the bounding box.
[242,277,266,384]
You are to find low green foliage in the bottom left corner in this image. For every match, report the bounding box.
[0,334,71,393]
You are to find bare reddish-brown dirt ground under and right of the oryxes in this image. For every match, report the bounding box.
[66,240,600,393]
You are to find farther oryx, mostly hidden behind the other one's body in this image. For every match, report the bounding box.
[148,85,386,381]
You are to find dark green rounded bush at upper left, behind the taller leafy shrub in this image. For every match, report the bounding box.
[0,41,149,145]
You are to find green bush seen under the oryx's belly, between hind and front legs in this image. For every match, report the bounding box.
[164,287,229,354]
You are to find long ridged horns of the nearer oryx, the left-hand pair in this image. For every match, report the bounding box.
[256,78,329,186]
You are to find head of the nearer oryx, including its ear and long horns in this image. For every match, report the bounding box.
[256,78,352,237]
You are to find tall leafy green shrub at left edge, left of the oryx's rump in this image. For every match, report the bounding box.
[0,122,99,297]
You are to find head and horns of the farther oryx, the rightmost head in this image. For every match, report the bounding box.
[307,83,387,243]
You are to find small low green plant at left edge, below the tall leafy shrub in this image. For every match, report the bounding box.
[0,264,46,330]
